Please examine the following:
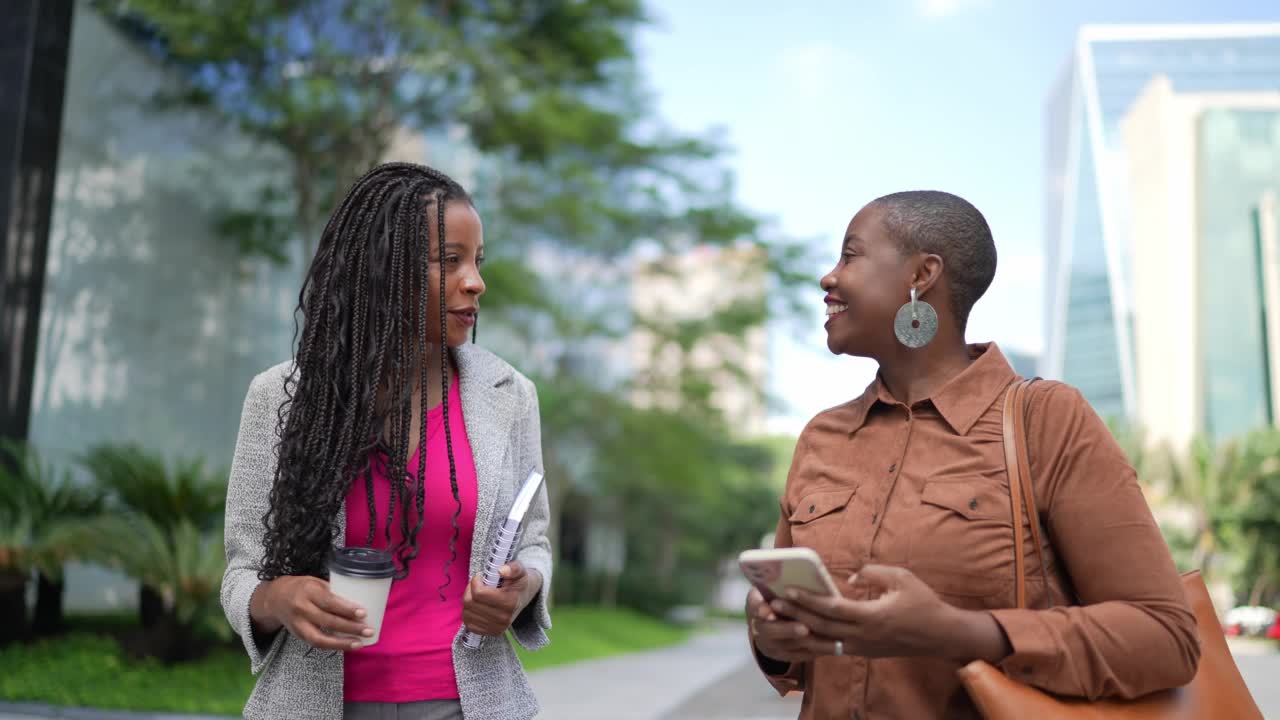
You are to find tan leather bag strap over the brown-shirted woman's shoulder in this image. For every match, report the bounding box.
[1004,378,1053,609]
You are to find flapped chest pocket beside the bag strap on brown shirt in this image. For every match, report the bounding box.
[908,477,1014,605]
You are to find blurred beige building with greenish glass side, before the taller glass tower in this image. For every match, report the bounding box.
[1121,76,1280,446]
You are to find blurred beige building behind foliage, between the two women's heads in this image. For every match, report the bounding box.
[628,245,768,437]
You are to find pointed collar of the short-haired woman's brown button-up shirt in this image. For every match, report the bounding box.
[849,342,1018,436]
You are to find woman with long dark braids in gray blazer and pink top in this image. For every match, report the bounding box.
[221,163,550,720]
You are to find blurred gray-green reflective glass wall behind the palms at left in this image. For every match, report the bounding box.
[28,3,302,611]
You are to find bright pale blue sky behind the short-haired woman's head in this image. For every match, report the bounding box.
[639,0,1280,434]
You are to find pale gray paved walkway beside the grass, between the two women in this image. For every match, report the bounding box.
[529,623,752,720]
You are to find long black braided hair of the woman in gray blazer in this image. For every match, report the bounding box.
[259,163,471,584]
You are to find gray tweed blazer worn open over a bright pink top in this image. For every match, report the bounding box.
[221,345,552,720]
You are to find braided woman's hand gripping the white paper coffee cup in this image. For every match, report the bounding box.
[251,575,374,650]
